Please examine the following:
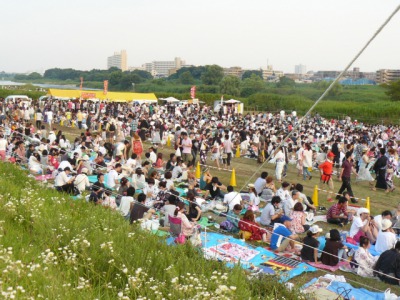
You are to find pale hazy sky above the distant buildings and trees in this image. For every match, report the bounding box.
[0,0,400,72]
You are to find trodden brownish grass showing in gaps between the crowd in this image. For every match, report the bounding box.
[55,124,400,294]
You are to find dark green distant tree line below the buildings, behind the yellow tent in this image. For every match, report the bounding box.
[10,65,352,97]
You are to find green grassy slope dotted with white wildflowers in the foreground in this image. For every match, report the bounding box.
[0,163,304,299]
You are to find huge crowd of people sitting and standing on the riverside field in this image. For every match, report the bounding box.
[0,99,400,281]
